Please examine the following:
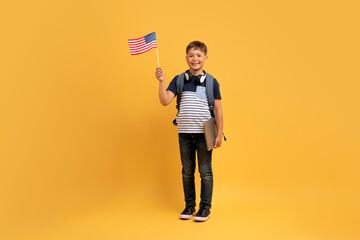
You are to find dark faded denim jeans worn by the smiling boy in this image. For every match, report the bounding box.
[179,133,213,209]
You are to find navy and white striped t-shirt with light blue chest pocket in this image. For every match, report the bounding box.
[167,73,221,133]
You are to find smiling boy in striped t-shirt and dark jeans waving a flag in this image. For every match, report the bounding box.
[155,41,223,221]
